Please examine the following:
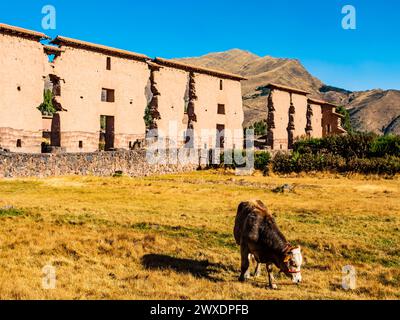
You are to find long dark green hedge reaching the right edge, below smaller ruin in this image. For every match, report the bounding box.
[272,133,400,175]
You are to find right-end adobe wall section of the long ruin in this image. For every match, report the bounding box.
[194,74,244,148]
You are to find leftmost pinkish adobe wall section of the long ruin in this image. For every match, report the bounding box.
[0,33,48,153]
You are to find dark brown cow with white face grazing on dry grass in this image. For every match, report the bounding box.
[234,200,303,289]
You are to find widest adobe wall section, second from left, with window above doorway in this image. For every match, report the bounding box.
[54,46,150,152]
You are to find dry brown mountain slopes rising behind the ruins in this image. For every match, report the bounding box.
[176,49,400,134]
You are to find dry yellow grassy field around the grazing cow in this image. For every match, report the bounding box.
[0,171,400,299]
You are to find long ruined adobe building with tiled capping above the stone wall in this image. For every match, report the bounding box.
[0,24,244,153]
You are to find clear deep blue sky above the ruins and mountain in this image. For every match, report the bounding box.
[0,0,400,90]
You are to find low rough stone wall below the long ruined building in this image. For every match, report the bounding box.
[0,150,198,178]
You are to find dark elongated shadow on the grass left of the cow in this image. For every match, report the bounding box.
[142,254,231,282]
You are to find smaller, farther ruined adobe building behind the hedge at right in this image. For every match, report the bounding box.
[267,84,346,150]
